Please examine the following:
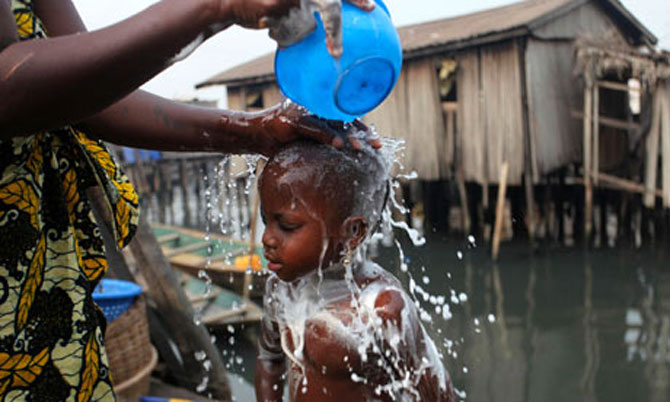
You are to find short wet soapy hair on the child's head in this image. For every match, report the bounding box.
[266,141,389,227]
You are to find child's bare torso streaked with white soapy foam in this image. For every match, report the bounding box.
[266,264,452,402]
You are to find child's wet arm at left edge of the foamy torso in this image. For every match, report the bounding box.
[256,316,286,402]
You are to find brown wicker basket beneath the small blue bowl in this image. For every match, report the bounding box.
[105,297,157,400]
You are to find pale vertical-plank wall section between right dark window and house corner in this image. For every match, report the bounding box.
[456,42,525,185]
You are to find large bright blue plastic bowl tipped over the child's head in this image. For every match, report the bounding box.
[275,0,402,122]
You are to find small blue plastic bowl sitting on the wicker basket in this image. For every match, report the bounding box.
[93,279,142,322]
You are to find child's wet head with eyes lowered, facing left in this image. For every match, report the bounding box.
[259,142,388,281]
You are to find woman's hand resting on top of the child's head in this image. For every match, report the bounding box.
[248,102,381,156]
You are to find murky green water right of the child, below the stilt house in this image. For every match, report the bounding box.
[220,232,670,402]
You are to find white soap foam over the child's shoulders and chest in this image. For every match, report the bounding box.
[266,261,448,400]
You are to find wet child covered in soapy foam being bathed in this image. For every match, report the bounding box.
[256,142,455,402]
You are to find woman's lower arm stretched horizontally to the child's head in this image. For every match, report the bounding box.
[82,91,342,155]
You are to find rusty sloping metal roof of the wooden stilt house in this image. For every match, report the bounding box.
[196,0,656,88]
